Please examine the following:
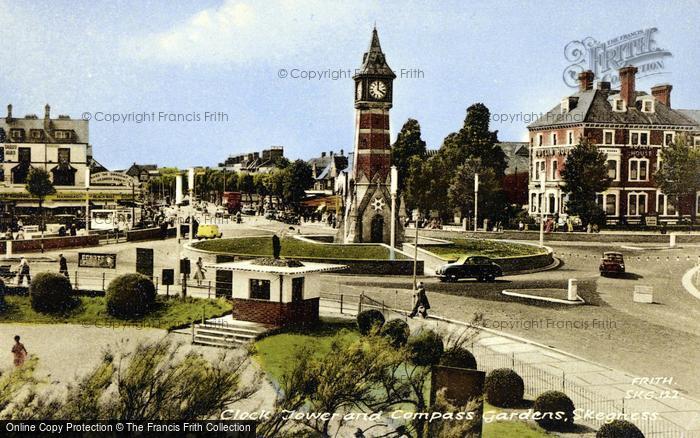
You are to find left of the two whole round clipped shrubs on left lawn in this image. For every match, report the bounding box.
[29,272,75,313]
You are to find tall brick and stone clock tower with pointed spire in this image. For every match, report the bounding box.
[339,28,403,244]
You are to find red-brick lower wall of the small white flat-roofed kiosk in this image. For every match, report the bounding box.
[230,298,319,326]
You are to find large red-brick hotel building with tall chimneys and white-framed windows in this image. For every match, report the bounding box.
[528,66,700,224]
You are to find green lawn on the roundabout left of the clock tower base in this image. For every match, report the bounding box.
[193,237,406,260]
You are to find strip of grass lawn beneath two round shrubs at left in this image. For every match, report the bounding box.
[0,295,231,330]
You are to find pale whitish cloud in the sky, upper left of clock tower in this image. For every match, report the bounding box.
[123,0,362,65]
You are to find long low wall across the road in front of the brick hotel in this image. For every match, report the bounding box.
[416,229,700,244]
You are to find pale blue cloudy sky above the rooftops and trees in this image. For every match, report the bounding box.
[0,0,700,169]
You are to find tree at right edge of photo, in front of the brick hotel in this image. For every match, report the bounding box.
[654,136,700,222]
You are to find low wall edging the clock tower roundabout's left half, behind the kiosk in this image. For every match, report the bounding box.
[183,244,424,275]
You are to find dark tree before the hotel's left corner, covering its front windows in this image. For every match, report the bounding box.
[561,138,611,225]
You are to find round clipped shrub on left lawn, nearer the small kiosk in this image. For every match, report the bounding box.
[107,274,156,318]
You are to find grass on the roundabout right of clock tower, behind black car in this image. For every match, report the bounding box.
[421,239,544,260]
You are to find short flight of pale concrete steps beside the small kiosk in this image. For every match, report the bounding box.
[192,317,269,348]
